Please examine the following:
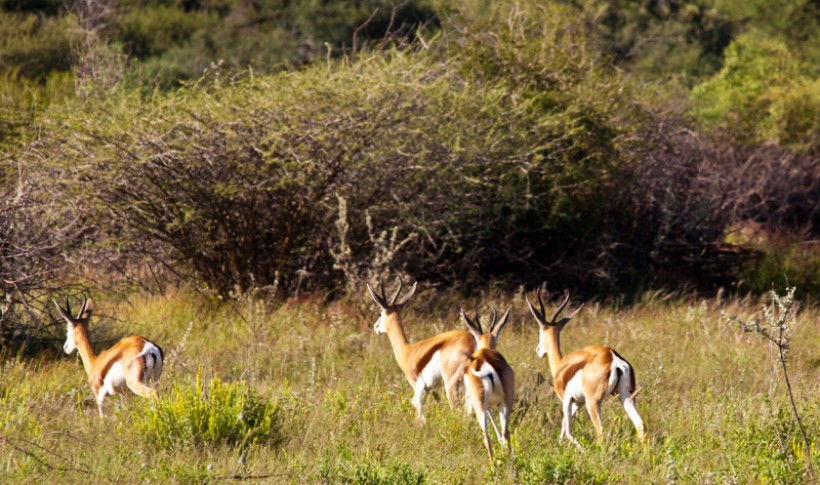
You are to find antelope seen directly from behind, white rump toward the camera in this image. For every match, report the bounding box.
[461,308,515,462]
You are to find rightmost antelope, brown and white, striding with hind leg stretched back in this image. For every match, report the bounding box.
[526,284,645,448]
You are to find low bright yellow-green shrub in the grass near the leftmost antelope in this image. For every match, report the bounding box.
[133,370,282,448]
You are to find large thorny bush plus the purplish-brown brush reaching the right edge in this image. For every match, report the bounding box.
[12,2,820,306]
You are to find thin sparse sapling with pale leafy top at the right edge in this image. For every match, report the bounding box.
[722,287,815,483]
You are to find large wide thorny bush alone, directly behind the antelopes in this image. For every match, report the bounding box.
[20,0,668,294]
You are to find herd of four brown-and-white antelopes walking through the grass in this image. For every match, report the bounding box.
[54,279,645,461]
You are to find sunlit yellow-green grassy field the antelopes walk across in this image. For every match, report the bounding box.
[0,289,820,484]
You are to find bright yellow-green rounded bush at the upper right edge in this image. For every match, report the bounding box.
[692,34,820,150]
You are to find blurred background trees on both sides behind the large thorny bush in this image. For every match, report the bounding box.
[0,0,820,151]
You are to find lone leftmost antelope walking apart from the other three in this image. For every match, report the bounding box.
[54,298,164,417]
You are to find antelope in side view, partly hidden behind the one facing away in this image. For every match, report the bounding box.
[367,279,475,422]
